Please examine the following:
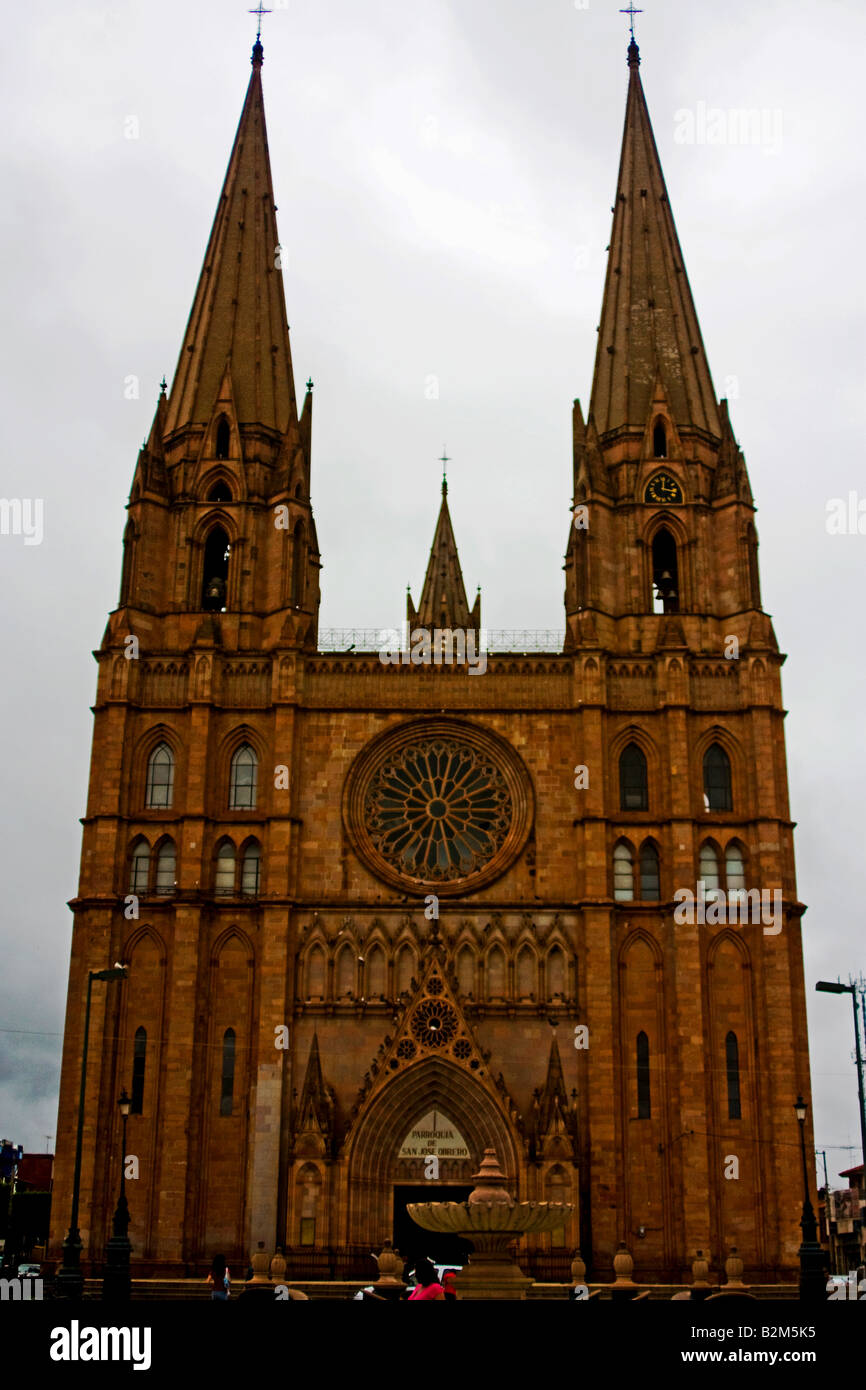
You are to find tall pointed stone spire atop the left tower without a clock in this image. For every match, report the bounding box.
[165,42,297,434]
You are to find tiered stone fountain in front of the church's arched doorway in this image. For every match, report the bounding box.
[406,1148,574,1298]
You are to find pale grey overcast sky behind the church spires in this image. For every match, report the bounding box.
[0,0,866,1180]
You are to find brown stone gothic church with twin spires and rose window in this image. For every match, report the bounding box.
[53,35,809,1280]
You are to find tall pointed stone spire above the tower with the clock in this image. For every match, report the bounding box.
[589,39,721,436]
